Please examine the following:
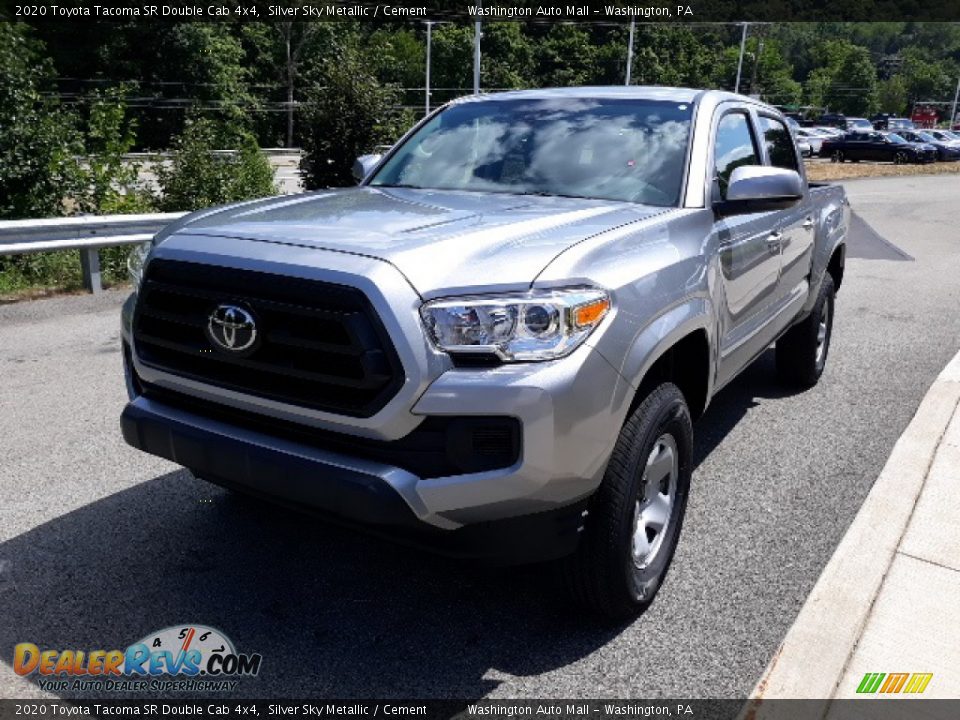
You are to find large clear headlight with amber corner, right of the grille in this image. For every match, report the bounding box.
[420,288,610,361]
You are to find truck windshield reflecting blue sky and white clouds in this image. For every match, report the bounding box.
[369,98,692,206]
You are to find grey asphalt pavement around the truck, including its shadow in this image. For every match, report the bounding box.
[0,175,960,699]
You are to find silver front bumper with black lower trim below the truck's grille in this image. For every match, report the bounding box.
[121,286,632,560]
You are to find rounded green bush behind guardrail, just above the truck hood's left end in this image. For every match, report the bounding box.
[157,118,277,212]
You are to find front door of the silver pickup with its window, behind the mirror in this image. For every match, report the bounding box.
[711,106,780,387]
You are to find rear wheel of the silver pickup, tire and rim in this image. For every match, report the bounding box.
[776,273,836,388]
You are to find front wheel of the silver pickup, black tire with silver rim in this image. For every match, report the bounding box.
[563,383,693,621]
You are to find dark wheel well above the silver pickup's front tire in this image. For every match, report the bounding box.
[630,330,710,420]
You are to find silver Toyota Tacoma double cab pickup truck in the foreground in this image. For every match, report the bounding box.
[122,87,849,618]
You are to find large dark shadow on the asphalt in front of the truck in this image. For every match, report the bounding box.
[0,472,618,698]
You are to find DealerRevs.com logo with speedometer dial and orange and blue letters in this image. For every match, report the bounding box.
[13,625,262,692]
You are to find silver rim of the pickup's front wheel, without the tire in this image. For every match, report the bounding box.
[631,435,679,570]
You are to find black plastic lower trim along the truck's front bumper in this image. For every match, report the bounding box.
[120,397,586,563]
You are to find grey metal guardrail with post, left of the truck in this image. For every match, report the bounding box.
[0,213,186,293]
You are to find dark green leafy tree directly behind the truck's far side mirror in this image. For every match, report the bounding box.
[300,48,412,189]
